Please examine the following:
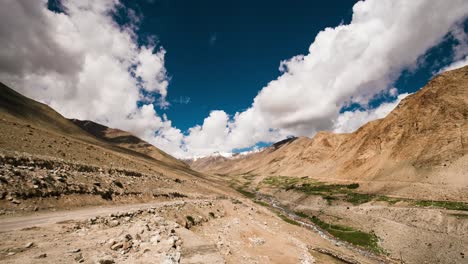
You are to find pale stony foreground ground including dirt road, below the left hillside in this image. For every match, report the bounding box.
[0,193,388,263]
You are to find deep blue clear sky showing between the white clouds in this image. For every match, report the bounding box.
[116,0,466,133]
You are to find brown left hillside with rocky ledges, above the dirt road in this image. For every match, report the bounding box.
[0,81,223,214]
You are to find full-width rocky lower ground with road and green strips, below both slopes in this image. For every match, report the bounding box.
[0,152,468,264]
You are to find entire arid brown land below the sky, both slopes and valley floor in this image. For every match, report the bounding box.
[0,67,468,264]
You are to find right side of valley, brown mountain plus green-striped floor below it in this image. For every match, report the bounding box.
[189,67,468,263]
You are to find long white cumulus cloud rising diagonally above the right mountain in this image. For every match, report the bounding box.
[180,0,468,157]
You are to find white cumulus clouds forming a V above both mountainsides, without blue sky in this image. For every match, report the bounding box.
[0,0,468,157]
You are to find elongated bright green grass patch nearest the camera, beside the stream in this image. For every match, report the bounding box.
[295,212,384,254]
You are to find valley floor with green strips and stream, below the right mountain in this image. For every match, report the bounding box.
[225,175,468,263]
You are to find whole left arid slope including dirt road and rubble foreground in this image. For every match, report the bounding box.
[0,82,384,263]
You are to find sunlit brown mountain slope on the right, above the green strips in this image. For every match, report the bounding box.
[192,67,468,200]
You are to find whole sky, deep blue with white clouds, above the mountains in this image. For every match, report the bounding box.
[0,0,468,158]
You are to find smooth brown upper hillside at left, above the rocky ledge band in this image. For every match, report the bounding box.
[0,83,187,170]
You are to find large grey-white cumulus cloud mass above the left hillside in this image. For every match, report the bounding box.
[0,0,183,155]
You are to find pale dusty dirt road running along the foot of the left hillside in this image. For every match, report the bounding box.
[0,199,205,232]
